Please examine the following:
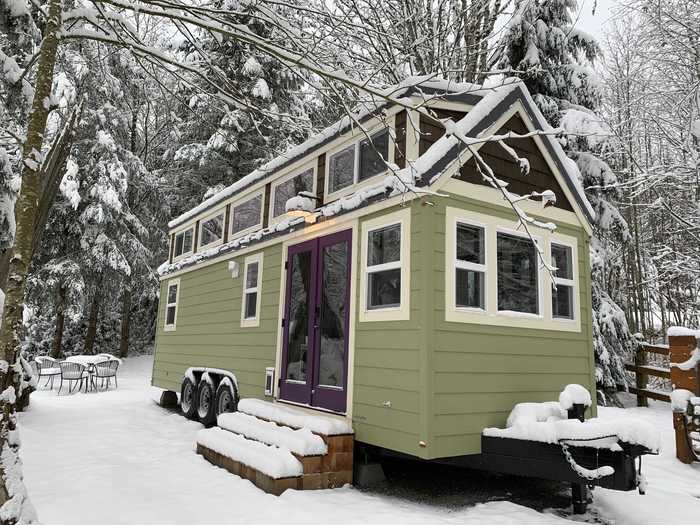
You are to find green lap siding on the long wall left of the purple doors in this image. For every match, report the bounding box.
[153,244,282,397]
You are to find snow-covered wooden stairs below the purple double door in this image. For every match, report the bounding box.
[197,399,354,495]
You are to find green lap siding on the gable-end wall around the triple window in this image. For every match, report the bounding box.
[428,192,595,458]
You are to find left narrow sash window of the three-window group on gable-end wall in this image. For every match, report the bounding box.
[455,222,486,310]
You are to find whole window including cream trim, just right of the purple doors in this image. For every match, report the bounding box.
[359,208,411,322]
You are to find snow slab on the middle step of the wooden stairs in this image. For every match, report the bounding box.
[217,412,328,456]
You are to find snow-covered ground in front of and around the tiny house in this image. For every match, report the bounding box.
[20,356,700,525]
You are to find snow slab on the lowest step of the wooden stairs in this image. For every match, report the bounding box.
[197,427,304,479]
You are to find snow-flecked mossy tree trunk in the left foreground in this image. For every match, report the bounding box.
[0,0,62,525]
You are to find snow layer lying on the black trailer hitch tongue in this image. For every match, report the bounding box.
[483,417,660,452]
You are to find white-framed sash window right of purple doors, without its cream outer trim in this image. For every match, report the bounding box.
[367,223,401,310]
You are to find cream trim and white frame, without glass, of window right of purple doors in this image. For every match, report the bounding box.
[359,207,411,322]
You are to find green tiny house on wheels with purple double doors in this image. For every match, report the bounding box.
[152,75,595,459]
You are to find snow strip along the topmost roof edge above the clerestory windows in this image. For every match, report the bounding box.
[168,75,491,228]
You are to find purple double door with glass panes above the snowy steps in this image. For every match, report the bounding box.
[280,230,352,412]
